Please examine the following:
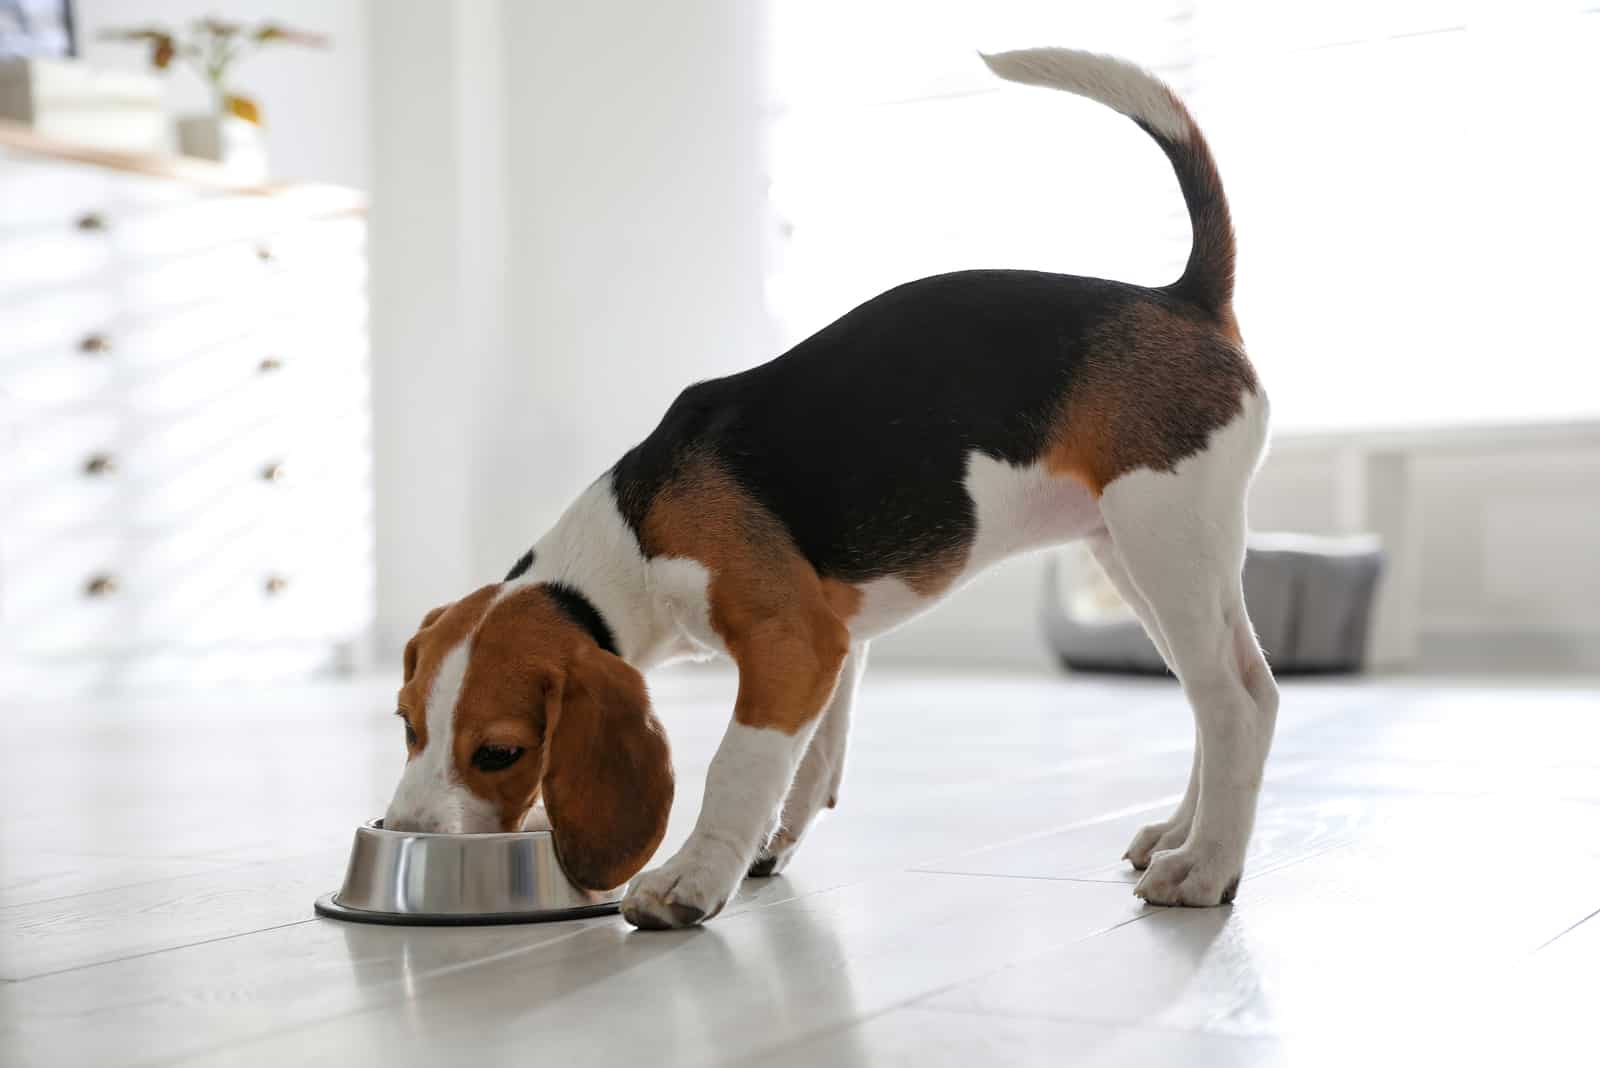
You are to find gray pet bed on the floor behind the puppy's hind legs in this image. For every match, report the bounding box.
[1042,534,1382,675]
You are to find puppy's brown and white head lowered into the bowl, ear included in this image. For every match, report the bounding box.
[384,585,672,889]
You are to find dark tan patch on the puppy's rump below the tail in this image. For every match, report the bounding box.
[1043,304,1258,496]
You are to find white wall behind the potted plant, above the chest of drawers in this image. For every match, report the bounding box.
[72,0,371,189]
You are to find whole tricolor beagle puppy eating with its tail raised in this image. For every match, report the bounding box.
[386,48,1277,929]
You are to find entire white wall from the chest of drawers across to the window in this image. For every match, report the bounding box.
[371,0,773,649]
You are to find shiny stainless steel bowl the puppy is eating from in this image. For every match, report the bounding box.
[317,820,626,924]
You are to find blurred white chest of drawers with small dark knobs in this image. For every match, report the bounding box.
[0,122,373,694]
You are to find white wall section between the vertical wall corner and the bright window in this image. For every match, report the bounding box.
[492,0,776,537]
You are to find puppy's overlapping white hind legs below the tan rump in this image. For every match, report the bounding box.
[1101,403,1277,905]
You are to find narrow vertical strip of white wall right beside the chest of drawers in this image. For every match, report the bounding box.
[370,0,506,652]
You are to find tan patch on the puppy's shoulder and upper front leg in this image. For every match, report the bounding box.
[643,456,861,734]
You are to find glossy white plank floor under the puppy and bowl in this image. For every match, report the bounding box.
[0,671,1600,1066]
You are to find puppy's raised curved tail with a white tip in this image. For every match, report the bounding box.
[979,48,1234,315]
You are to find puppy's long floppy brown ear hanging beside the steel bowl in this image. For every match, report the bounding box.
[542,644,672,891]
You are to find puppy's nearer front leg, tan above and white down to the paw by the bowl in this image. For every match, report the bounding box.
[622,617,848,931]
